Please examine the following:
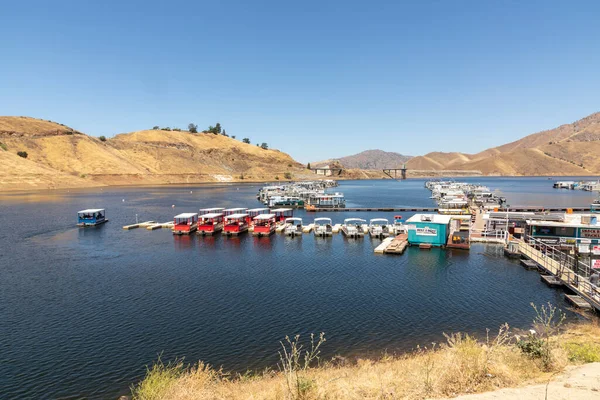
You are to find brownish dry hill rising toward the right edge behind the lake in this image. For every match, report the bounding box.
[407,113,600,175]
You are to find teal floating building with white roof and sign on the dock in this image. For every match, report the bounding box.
[406,214,451,247]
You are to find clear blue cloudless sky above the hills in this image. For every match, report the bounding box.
[0,0,600,162]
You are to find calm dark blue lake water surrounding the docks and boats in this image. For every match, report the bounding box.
[0,178,596,399]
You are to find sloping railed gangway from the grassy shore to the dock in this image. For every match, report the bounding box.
[518,237,600,311]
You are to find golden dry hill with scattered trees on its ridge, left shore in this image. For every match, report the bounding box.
[0,117,314,189]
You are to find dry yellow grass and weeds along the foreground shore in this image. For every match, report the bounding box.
[132,305,600,400]
